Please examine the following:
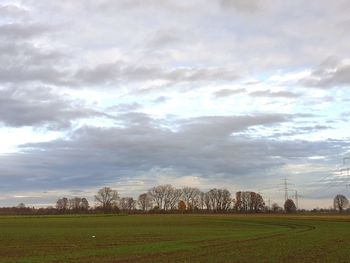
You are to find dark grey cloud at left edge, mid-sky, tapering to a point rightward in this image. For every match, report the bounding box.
[0,88,105,129]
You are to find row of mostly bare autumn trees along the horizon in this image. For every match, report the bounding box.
[0,184,349,214]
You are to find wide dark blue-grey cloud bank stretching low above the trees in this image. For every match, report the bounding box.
[0,114,346,196]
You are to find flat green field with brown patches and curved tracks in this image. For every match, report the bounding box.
[0,215,350,262]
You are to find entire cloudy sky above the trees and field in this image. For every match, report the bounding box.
[0,0,350,208]
